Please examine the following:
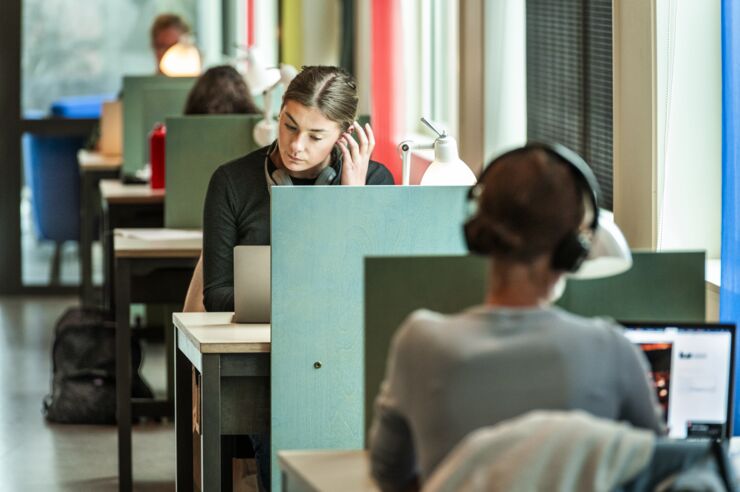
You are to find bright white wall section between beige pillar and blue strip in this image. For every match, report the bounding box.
[656,0,722,258]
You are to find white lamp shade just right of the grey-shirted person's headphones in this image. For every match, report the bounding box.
[569,210,632,279]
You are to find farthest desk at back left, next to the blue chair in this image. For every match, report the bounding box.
[77,149,123,307]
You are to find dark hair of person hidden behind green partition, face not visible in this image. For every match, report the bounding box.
[184,65,261,114]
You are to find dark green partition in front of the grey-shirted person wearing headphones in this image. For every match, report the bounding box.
[365,252,705,431]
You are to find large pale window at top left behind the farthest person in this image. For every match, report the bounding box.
[22,0,202,113]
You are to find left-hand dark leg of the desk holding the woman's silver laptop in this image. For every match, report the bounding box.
[174,329,193,492]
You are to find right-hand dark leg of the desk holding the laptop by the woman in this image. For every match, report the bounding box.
[200,354,221,492]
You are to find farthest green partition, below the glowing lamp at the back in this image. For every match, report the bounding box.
[123,75,195,174]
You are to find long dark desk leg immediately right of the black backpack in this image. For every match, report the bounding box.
[115,259,133,492]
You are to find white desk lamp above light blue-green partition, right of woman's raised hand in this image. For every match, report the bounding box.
[399,117,476,186]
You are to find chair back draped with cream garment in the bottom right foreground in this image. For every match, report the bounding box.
[423,411,734,492]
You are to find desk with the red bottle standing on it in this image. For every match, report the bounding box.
[99,179,165,312]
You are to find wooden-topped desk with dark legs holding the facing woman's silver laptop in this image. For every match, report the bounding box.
[172,313,270,492]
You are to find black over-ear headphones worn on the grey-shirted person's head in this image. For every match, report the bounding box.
[465,143,600,272]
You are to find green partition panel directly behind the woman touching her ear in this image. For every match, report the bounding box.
[164,115,261,229]
